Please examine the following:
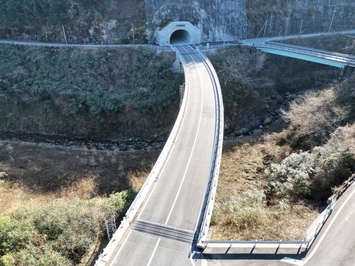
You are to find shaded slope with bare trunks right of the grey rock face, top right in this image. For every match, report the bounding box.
[246,0,355,37]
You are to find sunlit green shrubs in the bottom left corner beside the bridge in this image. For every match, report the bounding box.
[0,191,134,266]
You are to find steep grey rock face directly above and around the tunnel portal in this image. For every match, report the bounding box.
[145,0,246,42]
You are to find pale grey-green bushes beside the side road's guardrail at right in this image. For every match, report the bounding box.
[266,126,355,201]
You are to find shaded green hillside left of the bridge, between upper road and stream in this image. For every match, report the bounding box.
[0,45,183,138]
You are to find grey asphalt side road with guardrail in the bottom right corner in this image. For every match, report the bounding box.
[189,184,355,266]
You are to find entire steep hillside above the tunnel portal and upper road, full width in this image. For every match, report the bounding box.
[0,0,355,44]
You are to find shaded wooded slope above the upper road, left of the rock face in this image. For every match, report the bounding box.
[0,0,146,43]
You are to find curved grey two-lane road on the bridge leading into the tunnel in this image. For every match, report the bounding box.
[97,45,223,266]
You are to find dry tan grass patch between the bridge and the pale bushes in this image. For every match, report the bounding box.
[211,135,318,240]
